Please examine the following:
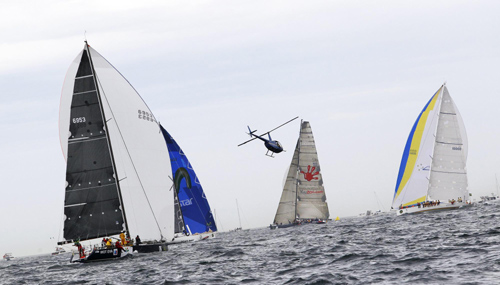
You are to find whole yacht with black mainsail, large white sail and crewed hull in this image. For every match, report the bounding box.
[58,42,174,262]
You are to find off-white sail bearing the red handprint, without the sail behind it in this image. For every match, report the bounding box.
[297,121,330,219]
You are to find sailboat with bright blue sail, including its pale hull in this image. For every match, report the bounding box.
[160,125,217,243]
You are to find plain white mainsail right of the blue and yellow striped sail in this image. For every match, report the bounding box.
[428,86,469,202]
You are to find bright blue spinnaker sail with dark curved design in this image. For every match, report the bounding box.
[160,125,217,234]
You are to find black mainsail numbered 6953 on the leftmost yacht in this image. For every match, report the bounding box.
[64,45,126,240]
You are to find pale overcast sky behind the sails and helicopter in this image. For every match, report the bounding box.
[0,0,500,255]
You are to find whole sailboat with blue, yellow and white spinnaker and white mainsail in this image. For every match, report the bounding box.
[392,85,469,215]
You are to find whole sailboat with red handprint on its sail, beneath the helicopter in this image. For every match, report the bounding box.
[270,121,330,226]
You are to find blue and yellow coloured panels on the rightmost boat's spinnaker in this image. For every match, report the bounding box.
[394,88,441,205]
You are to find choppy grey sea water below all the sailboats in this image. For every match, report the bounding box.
[0,202,500,284]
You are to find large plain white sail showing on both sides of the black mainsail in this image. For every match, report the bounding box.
[59,45,174,240]
